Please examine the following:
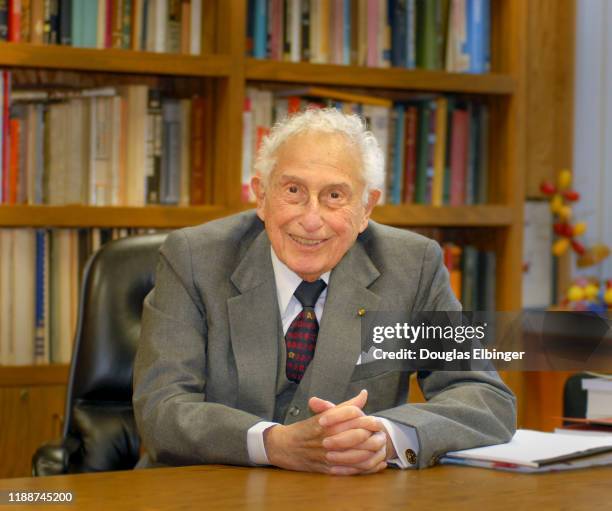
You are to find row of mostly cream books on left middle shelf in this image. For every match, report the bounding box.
[0,71,204,206]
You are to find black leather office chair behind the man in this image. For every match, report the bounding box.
[32,234,166,476]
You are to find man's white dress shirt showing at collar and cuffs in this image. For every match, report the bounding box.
[247,248,419,468]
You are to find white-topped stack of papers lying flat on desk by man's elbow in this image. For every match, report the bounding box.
[440,429,612,473]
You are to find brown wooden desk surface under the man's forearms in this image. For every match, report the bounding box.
[0,465,612,511]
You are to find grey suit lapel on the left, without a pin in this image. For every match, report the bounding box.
[227,231,280,420]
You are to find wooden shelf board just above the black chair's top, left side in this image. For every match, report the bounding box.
[0,205,235,228]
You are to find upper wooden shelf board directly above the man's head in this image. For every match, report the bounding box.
[245,58,516,95]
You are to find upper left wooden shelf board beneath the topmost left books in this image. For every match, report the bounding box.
[0,43,231,77]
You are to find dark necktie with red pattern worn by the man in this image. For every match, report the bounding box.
[285,279,327,383]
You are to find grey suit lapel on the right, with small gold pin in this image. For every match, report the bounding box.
[286,238,381,423]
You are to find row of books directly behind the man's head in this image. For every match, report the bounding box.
[242,87,489,206]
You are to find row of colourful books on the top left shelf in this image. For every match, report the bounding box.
[0,0,202,55]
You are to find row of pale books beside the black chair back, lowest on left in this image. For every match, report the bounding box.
[0,228,163,365]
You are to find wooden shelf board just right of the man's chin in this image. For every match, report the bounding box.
[372,204,514,227]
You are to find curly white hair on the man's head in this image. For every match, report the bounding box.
[255,108,385,203]
